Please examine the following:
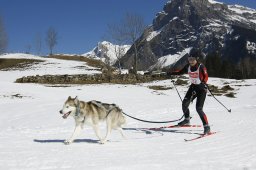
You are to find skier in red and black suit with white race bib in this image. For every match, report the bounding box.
[171,49,210,134]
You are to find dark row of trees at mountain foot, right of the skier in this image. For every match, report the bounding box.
[200,53,256,79]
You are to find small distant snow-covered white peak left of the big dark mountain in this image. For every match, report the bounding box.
[82,41,130,65]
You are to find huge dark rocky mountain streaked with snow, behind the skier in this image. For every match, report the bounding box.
[121,0,256,70]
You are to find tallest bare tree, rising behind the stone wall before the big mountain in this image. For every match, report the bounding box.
[109,13,146,73]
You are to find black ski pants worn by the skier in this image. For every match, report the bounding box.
[182,84,208,125]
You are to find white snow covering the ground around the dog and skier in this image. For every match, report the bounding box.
[0,54,256,170]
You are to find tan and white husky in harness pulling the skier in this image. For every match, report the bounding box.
[60,96,126,144]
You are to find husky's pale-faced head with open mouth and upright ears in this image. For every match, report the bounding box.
[60,96,79,119]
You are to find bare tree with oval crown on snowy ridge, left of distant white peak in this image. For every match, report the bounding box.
[46,27,58,55]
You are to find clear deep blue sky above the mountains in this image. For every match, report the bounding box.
[0,0,256,54]
